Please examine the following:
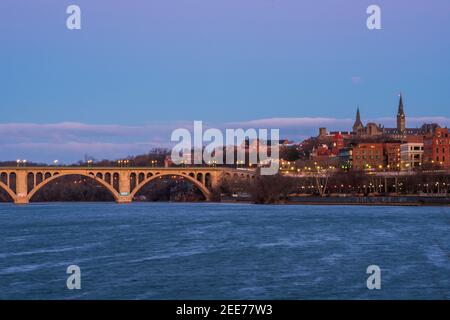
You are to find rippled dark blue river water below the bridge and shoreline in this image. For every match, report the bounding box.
[0,203,450,299]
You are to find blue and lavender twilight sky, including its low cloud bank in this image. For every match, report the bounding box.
[0,0,450,163]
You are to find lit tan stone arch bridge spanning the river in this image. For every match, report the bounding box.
[0,167,256,204]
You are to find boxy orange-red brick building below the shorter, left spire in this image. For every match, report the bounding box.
[352,143,384,170]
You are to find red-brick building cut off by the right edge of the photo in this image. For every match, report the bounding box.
[423,128,450,169]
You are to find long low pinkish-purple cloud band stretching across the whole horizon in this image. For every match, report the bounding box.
[0,117,450,163]
